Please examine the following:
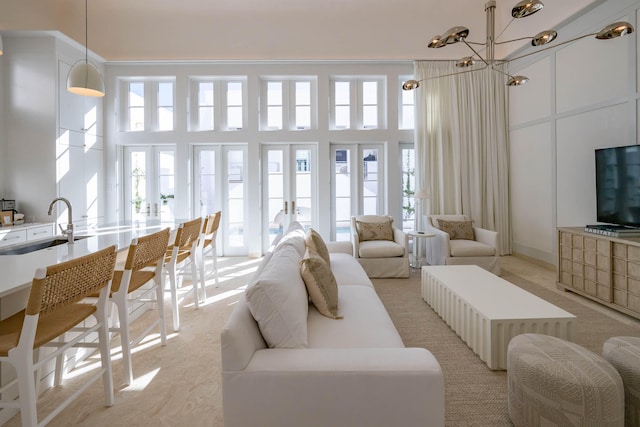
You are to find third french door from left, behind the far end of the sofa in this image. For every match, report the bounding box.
[262,144,317,251]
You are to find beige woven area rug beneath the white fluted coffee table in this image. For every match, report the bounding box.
[373,271,640,427]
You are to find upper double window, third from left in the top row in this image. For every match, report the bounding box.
[260,77,316,130]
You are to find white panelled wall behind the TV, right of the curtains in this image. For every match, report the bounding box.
[509,0,640,264]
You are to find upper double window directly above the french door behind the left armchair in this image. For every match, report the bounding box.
[331,77,386,129]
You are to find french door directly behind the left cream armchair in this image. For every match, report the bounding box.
[331,144,384,240]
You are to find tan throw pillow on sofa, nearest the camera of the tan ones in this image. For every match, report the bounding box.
[300,249,342,319]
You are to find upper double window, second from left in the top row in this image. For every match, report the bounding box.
[189,77,246,132]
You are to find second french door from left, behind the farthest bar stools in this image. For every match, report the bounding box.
[193,144,248,256]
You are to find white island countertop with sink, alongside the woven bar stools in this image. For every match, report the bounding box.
[0,221,179,298]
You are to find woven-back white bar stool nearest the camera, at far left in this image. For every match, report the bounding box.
[0,246,116,427]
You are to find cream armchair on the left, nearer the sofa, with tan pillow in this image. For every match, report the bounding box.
[351,215,409,278]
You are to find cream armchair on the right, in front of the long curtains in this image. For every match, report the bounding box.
[424,215,501,276]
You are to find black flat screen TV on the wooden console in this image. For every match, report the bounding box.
[596,145,640,227]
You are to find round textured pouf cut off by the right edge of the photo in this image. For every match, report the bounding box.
[602,337,640,426]
